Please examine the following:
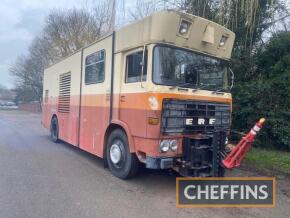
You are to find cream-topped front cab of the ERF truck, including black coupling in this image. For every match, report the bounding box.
[111,11,235,176]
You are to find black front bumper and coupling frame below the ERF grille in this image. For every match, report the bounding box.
[146,132,226,177]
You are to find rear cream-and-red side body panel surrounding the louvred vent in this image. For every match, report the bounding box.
[42,51,81,146]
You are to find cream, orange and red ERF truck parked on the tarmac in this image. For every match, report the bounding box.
[42,10,235,179]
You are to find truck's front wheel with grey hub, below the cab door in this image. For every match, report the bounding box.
[106,129,140,179]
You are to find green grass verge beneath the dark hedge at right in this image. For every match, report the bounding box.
[244,148,290,177]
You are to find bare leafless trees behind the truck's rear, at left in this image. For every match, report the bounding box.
[10,1,114,105]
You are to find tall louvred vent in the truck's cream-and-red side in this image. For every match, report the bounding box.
[58,73,71,113]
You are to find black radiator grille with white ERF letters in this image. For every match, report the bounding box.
[161,99,230,134]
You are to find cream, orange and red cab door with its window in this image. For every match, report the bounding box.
[119,47,147,137]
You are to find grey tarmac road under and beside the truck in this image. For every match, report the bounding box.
[0,111,290,218]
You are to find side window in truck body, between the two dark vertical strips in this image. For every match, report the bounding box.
[85,50,105,85]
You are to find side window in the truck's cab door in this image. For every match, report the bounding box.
[126,51,147,83]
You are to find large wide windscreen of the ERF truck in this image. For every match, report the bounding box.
[153,45,228,90]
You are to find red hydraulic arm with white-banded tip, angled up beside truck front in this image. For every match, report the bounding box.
[222,118,266,169]
